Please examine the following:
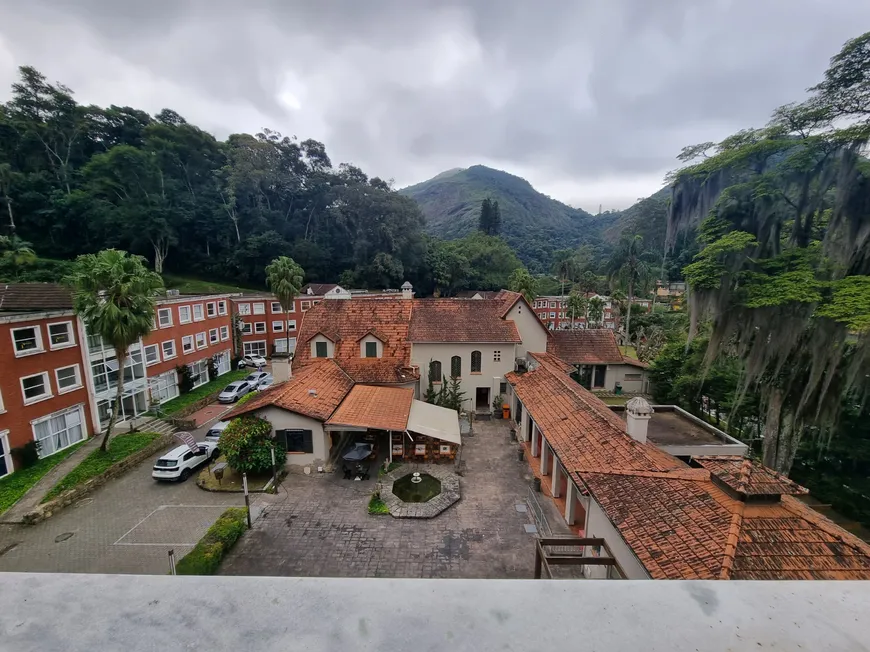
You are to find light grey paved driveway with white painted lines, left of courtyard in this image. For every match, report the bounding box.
[0,408,267,574]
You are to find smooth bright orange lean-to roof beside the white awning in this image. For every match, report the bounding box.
[326,385,414,431]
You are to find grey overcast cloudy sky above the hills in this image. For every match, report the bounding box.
[0,0,870,212]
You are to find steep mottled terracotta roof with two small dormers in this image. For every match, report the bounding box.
[294,297,418,383]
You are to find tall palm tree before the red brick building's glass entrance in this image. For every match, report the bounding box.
[64,249,163,451]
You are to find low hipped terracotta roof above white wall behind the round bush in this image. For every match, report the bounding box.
[230,359,353,421]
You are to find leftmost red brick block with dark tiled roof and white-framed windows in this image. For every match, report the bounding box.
[0,283,95,477]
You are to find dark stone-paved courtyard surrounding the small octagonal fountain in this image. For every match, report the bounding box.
[220,421,564,578]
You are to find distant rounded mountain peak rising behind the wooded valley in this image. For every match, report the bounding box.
[399,165,613,272]
